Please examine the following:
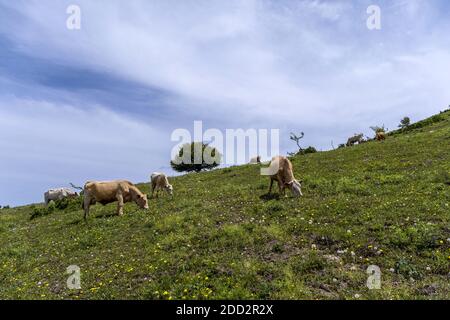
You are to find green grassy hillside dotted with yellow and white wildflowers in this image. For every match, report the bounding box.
[0,112,450,299]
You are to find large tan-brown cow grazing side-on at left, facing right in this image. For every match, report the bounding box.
[83,180,148,220]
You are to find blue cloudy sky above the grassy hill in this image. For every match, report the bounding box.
[0,0,450,205]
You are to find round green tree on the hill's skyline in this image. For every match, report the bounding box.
[170,142,222,172]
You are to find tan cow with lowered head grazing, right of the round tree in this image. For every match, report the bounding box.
[269,156,303,197]
